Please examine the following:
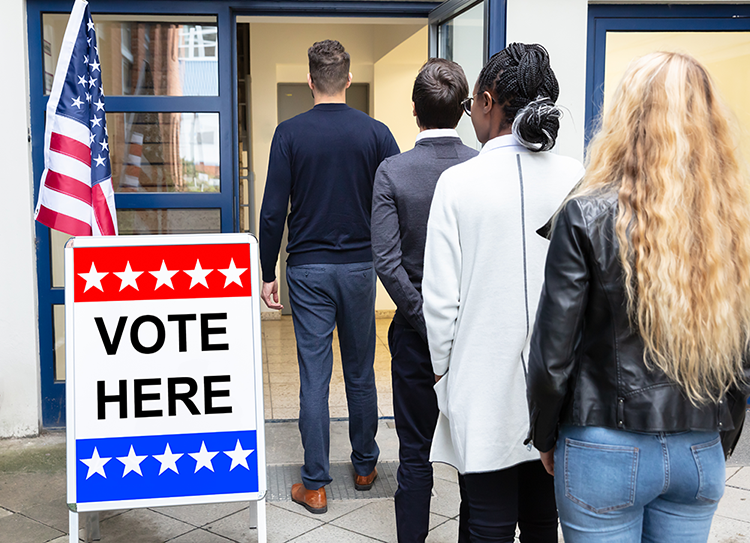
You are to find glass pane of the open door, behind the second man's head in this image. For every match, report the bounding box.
[438,2,484,149]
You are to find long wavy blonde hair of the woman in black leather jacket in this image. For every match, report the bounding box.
[577,53,750,404]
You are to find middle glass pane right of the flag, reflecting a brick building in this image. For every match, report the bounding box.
[107,112,220,192]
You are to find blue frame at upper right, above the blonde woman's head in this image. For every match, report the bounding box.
[585,4,750,143]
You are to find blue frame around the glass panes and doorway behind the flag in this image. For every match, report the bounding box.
[27,0,468,428]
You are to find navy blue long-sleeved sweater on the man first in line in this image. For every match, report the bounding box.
[259,104,399,282]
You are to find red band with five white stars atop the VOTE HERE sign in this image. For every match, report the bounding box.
[74,244,253,303]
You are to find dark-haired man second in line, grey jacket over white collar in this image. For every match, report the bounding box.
[372,58,477,543]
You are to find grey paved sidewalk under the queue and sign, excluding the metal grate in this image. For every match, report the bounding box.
[0,416,750,543]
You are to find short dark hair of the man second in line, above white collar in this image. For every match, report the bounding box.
[411,58,469,128]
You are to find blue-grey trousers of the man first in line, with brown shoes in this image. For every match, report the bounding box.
[286,262,380,490]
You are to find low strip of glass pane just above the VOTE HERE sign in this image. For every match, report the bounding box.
[117,209,221,235]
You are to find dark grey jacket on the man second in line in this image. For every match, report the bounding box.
[371,137,477,341]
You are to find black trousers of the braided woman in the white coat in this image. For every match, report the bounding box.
[462,460,557,543]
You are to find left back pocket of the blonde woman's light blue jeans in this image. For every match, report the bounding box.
[564,438,638,513]
